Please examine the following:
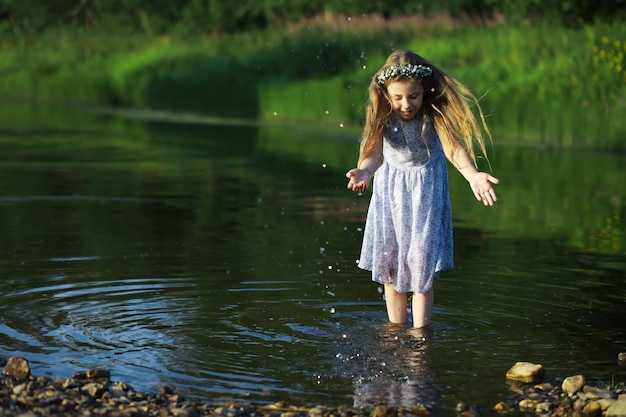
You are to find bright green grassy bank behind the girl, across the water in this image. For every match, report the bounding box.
[0,16,626,150]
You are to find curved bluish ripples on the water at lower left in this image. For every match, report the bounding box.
[0,276,194,385]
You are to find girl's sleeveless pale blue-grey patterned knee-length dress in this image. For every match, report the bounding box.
[358,113,454,293]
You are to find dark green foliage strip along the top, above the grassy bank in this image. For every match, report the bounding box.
[0,0,626,35]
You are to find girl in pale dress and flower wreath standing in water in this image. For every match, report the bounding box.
[346,51,499,328]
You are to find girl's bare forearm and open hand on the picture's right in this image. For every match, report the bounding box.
[447,143,500,206]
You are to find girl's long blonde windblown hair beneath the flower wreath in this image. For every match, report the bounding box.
[359,51,491,168]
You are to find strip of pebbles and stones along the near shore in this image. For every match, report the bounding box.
[0,357,626,417]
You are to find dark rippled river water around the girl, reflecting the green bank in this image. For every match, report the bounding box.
[0,102,626,414]
